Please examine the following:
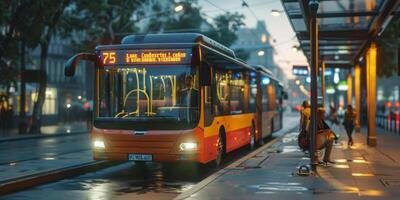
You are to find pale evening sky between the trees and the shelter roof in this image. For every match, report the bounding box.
[198,0,307,79]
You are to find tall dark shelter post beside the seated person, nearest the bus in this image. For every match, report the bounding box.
[308,0,319,172]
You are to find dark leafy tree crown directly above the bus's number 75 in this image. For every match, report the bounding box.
[63,0,146,51]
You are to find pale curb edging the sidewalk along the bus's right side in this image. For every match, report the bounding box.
[174,125,297,200]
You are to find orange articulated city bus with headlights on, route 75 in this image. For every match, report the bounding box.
[65,33,284,165]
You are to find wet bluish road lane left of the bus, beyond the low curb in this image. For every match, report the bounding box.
[0,133,91,165]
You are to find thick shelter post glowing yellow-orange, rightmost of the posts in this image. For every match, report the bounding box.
[366,42,377,147]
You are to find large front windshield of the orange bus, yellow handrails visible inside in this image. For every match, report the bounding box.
[95,65,199,129]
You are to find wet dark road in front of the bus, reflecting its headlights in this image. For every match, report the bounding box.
[0,139,272,200]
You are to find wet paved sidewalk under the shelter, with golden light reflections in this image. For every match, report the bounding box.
[177,124,400,200]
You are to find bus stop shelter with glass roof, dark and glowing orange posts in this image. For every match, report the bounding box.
[281,0,400,170]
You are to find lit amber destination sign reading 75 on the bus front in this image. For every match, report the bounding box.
[100,49,190,65]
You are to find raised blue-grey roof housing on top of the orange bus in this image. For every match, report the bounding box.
[121,33,236,58]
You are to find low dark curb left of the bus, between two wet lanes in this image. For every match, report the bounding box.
[0,161,119,195]
